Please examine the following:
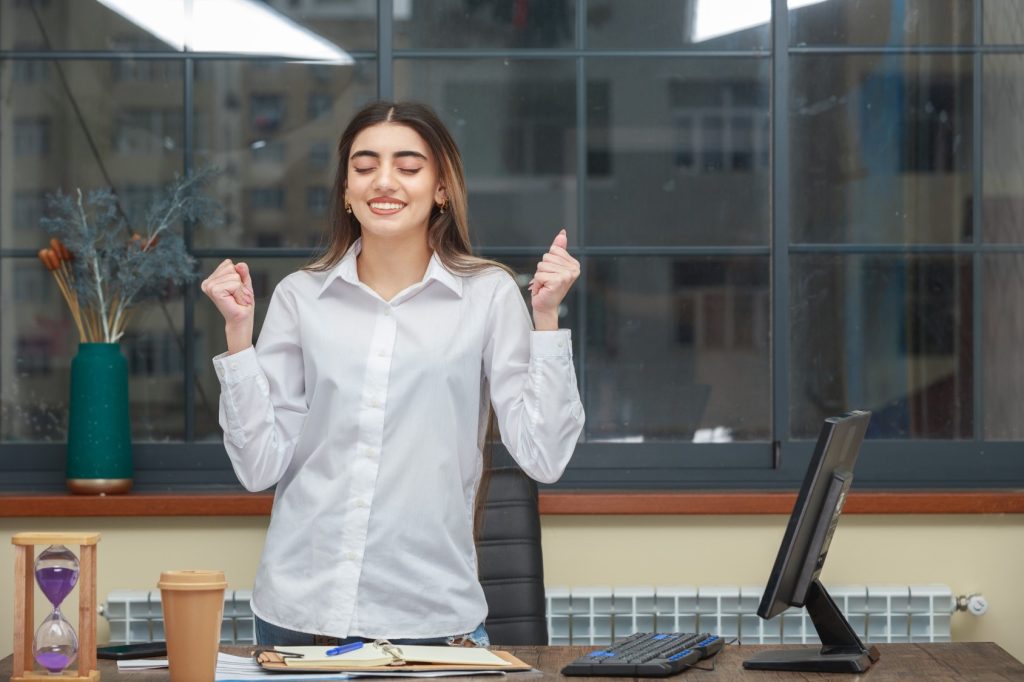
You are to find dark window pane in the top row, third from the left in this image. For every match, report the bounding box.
[394,0,577,49]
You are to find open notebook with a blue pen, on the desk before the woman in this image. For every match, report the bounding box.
[256,640,530,672]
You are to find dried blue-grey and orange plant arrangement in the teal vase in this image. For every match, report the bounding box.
[39,168,222,343]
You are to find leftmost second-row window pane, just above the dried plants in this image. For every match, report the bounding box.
[0,60,184,250]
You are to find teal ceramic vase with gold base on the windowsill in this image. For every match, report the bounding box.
[68,343,132,495]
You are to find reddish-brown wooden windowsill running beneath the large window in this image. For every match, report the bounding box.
[0,489,1024,517]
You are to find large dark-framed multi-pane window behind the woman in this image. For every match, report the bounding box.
[0,0,1024,489]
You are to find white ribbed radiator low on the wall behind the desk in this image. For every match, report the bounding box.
[100,585,955,645]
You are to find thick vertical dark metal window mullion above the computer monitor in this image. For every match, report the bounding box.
[769,0,792,466]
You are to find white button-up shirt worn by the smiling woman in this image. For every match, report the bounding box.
[213,243,584,637]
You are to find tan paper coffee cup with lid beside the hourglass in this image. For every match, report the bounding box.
[157,570,227,682]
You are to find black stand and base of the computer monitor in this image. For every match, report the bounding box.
[743,579,879,673]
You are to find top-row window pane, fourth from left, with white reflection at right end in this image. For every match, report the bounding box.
[587,0,771,50]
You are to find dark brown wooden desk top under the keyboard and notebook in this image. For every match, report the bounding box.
[0,642,1024,682]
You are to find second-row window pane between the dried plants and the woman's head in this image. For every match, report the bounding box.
[195,61,377,247]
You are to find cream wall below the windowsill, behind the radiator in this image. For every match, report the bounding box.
[0,515,1024,659]
